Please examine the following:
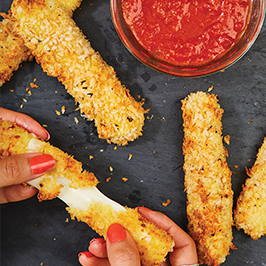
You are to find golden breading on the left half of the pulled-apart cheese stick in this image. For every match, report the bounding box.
[0,120,99,196]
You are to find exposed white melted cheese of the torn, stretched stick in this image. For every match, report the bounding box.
[27,138,126,211]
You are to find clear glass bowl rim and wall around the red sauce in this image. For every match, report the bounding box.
[111,0,265,77]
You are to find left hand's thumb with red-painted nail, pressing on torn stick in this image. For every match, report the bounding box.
[0,153,55,187]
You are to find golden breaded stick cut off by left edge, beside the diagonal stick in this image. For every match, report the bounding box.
[0,13,30,87]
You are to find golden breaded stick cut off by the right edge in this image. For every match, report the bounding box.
[234,138,266,239]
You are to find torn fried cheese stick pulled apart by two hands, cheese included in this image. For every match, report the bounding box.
[0,119,174,266]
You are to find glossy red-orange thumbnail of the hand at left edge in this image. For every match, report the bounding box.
[30,154,55,175]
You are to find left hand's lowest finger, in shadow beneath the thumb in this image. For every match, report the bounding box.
[0,184,38,204]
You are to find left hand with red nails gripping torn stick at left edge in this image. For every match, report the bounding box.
[0,107,54,203]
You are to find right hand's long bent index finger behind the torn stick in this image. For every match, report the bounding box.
[138,207,198,266]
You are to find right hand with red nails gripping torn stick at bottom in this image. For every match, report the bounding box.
[79,207,198,266]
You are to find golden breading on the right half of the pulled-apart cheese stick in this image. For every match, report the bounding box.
[67,202,174,266]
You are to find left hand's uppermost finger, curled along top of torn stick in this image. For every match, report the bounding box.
[0,107,50,140]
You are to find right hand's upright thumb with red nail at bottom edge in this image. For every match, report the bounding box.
[106,223,140,266]
